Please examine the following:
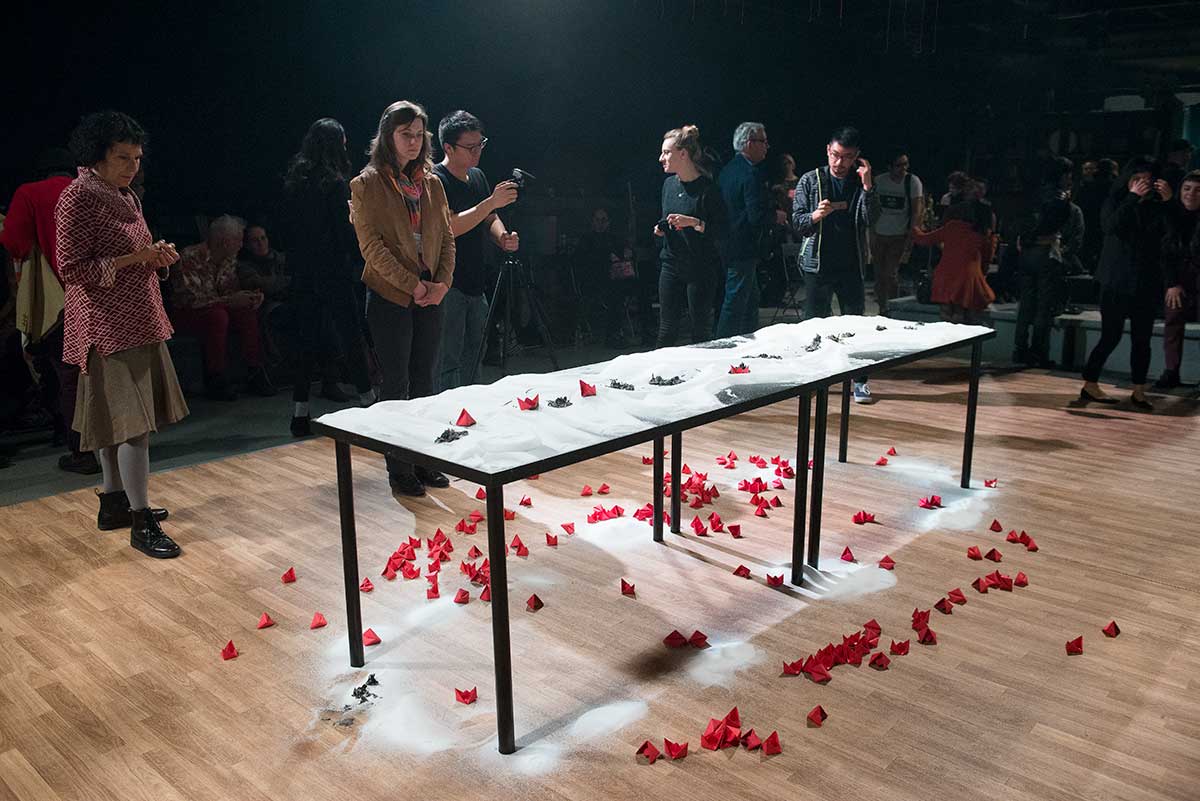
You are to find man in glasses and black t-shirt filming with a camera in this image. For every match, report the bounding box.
[433,110,520,391]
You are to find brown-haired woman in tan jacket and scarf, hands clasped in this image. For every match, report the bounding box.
[350,101,454,495]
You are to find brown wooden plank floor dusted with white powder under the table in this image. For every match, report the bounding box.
[0,365,1200,801]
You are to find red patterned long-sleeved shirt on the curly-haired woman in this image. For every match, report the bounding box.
[54,168,174,373]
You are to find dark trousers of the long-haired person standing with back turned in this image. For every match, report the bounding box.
[292,284,371,403]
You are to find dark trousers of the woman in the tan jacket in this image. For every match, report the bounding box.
[367,291,442,475]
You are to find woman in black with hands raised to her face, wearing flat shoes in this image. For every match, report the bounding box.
[1079,157,1174,411]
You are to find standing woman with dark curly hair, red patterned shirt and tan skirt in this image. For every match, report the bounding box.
[54,112,187,559]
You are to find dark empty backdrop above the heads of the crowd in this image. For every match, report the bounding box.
[7,0,1200,241]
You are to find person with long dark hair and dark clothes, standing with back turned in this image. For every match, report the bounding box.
[283,118,374,436]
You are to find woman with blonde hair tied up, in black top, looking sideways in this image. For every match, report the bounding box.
[654,125,725,348]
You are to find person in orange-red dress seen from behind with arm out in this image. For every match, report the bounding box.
[912,190,996,323]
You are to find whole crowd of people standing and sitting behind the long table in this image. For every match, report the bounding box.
[0,101,1200,558]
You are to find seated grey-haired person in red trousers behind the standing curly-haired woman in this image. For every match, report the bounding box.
[170,215,275,401]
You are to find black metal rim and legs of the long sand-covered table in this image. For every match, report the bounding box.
[312,323,996,754]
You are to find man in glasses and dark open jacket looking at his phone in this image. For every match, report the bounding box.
[792,127,881,403]
